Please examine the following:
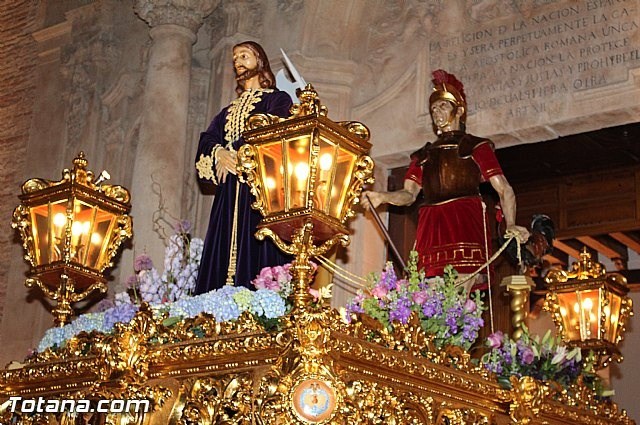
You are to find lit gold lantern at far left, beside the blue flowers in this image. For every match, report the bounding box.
[12,152,132,326]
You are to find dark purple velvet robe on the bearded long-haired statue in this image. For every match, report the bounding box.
[195,89,292,294]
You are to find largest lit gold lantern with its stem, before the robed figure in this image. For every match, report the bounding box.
[238,84,373,308]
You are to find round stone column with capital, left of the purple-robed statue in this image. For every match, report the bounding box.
[131,0,219,266]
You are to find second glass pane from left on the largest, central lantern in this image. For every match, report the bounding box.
[283,135,311,210]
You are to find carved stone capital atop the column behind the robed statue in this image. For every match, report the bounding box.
[134,0,220,34]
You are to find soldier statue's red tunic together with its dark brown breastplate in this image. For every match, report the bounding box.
[405,131,502,284]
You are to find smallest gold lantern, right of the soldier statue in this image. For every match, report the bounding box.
[544,248,633,367]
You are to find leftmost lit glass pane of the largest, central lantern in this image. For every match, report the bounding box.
[258,141,285,214]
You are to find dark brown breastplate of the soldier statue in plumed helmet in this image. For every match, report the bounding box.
[422,144,481,205]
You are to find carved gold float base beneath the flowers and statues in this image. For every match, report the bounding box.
[0,305,635,425]
